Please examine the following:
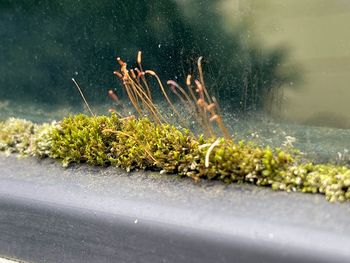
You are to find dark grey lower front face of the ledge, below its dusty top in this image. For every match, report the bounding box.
[0,196,346,263]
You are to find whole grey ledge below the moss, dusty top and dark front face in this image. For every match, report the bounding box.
[0,155,350,262]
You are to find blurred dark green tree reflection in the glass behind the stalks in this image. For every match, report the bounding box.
[0,0,293,110]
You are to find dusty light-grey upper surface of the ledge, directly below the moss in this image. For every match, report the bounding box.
[0,155,350,257]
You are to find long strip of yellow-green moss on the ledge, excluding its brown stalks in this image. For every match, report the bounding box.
[0,114,350,201]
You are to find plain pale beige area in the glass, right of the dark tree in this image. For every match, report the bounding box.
[219,0,350,128]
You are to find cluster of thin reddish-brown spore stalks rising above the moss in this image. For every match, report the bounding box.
[111,51,231,139]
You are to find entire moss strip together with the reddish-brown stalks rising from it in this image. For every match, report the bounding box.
[0,53,350,202]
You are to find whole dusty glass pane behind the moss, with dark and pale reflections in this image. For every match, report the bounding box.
[0,0,350,165]
